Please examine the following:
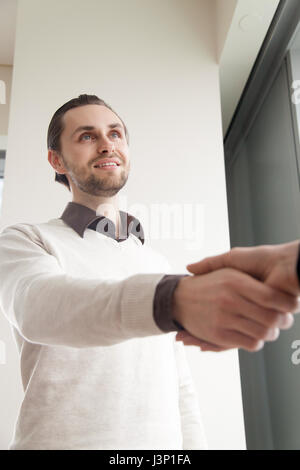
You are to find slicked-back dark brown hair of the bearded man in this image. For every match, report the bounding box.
[47,95,129,191]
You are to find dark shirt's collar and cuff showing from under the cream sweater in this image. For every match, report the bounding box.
[60,202,188,333]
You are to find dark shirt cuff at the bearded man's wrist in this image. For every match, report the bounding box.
[153,274,189,333]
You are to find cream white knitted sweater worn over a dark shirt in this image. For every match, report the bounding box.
[0,219,207,450]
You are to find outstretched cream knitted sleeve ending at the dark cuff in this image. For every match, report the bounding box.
[0,224,165,348]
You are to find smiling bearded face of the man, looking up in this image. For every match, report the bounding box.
[48,104,130,197]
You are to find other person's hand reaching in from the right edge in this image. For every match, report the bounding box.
[176,241,300,351]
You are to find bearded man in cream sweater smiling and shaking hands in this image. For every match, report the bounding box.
[0,95,297,449]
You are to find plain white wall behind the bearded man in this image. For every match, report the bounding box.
[0,0,245,449]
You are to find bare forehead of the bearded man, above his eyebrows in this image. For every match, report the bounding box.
[63,104,123,132]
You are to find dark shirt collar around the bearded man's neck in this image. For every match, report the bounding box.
[60,202,145,244]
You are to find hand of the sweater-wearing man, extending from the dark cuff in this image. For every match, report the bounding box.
[173,268,298,351]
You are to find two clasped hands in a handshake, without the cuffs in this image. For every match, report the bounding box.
[172,240,300,352]
